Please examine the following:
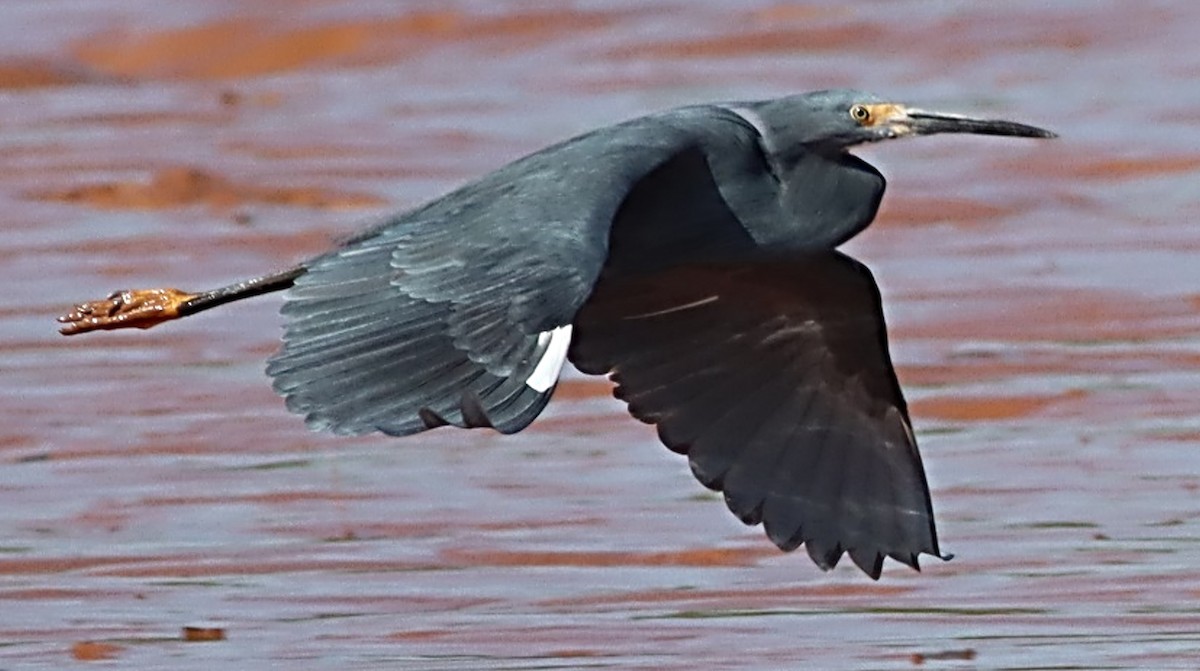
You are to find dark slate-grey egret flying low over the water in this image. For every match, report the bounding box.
[59,89,1056,580]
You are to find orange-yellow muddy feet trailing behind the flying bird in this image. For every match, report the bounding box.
[59,289,196,335]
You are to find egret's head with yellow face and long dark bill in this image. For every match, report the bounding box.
[756,89,1057,150]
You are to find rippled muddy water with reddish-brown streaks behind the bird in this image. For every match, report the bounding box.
[0,0,1200,669]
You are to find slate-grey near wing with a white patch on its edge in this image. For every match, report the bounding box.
[268,107,756,435]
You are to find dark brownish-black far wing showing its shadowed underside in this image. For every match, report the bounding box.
[570,252,938,579]
